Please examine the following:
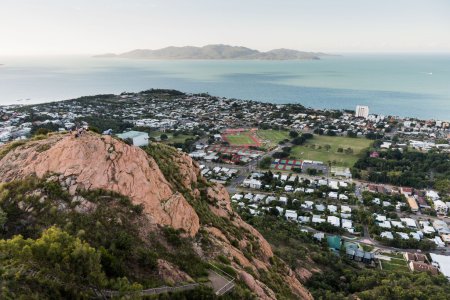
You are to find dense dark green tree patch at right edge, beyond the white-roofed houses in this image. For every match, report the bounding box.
[352,150,450,190]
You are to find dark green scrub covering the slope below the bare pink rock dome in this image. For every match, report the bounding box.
[0,178,215,299]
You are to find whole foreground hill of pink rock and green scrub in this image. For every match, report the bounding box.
[0,132,311,299]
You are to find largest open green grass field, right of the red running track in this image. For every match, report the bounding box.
[291,135,372,167]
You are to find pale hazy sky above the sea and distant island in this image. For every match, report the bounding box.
[0,0,450,55]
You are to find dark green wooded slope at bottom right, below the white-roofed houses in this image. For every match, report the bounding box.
[241,214,450,300]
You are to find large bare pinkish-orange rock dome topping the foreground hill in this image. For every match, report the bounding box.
[0,133,200,236]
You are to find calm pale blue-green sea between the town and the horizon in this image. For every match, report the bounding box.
[0,54,450,120]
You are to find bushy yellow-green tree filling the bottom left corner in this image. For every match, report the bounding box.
[0,227,107,298]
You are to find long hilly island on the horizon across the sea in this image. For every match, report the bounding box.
[94,45,329,60]
